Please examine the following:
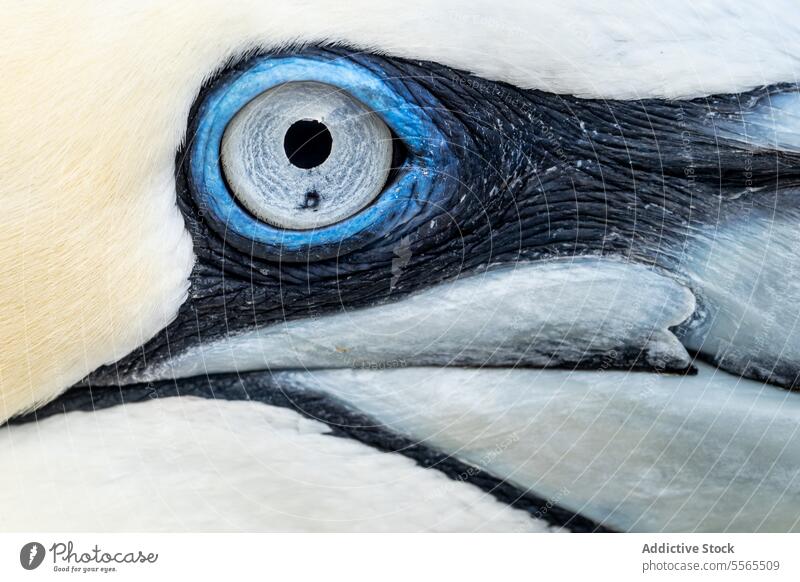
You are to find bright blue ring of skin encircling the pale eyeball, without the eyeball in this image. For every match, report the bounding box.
[189,56,457,261]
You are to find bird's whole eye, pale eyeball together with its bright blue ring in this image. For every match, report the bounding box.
[188,56,455,260]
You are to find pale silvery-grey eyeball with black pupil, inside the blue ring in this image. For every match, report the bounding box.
[222,82,392,230]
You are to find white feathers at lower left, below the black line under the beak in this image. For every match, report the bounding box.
[0,397,549,531]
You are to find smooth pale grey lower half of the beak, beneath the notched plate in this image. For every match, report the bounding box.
[278,364,800,532]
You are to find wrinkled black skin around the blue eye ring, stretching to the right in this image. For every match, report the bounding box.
[86,48,800,383]
